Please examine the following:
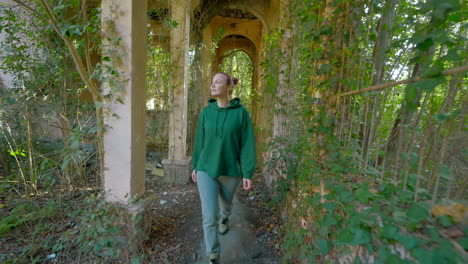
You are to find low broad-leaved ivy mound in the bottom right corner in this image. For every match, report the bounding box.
[282,134,465,263]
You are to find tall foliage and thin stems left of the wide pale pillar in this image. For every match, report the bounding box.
[0,1,103,191]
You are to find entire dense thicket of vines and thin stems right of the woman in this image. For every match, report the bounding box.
[264,0,467,263]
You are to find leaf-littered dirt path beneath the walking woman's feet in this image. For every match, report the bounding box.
[146,174,280,264]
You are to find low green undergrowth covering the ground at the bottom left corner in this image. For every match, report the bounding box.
[0,191,145,263]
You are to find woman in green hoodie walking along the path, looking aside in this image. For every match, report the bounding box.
[192,73,255,263]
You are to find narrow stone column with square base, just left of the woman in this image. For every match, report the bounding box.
[163,0,192,184]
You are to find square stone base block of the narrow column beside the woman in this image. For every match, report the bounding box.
[162,157,192,184]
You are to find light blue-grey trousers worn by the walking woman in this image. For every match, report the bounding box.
[197,171,242,255]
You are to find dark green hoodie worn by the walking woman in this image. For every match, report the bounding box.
[192,98,255,179]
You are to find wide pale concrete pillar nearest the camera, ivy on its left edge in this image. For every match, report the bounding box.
[102,0,147,203]
